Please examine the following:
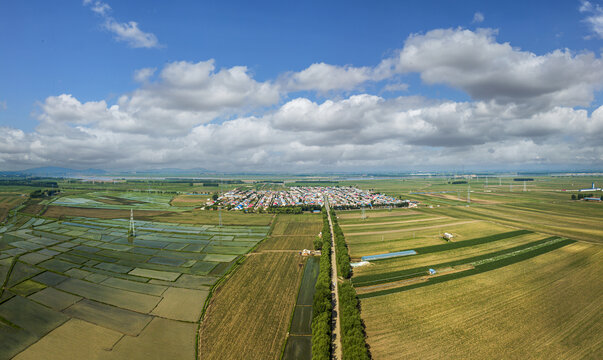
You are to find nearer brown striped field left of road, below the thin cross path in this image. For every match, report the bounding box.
[199,253,303,359]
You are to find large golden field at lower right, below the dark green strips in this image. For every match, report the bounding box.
[362,243,603,359]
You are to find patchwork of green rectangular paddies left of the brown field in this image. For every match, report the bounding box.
[0,218,268,359]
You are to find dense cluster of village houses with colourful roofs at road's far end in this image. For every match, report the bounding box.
[215,186,407,210]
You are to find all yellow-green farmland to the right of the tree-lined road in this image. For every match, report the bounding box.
[338,178,603,359]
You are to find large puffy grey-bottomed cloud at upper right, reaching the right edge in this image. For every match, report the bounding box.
[387,28,603,107]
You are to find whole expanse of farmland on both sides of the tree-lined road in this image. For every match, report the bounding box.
[0,177,603,359]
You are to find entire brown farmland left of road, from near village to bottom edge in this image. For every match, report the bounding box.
[199,214,322,359]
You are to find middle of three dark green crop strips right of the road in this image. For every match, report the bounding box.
[352,236,558,287]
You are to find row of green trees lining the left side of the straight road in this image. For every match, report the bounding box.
[312,208,332,360]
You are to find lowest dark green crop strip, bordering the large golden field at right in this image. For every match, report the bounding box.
[358,239,575,299]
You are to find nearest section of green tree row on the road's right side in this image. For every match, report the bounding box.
[339,281,371,359]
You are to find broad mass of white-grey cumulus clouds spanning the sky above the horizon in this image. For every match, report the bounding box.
[0,29,603,172]
